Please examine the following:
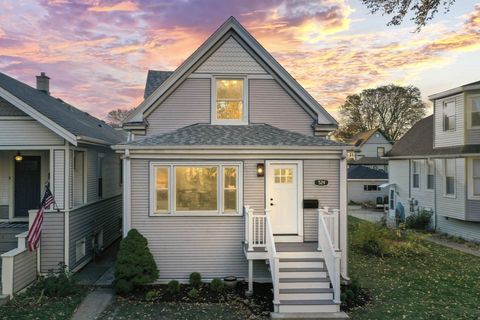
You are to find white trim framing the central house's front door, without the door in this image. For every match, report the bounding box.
[265,160,303,242]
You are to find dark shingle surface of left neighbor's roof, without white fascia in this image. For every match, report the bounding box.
[0,72,124,144]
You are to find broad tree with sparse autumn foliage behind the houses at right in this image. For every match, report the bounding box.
[335,84,427,141]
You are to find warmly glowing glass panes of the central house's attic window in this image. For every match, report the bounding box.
[215,79,245,121]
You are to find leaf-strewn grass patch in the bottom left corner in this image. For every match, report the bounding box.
[0,287,88,320]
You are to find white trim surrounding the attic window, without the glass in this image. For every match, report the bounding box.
[210,75,249,125]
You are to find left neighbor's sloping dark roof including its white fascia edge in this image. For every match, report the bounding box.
[0,72,124,145]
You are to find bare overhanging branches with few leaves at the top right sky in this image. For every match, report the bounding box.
[362,0,455,32]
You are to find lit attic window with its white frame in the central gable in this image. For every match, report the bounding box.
[212,78,248,124]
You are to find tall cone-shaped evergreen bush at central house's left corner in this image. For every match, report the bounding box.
[114,229,158,293]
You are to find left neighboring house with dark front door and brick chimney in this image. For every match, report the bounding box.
[0,73,124,291]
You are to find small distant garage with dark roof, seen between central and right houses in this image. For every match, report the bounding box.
[348,165,388,204]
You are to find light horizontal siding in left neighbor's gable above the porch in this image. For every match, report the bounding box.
[0,118,63,146]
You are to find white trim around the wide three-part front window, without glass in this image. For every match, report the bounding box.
[149,161,243,217]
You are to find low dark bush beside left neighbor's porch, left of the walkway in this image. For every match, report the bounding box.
[38,263,78,297]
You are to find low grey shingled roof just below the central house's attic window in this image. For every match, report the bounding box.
[123,124,348,147]
